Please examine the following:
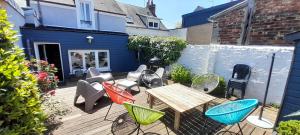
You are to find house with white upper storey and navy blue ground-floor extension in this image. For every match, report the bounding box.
[21,0,136,80]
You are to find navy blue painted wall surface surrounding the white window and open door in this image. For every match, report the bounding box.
[21,28,137,78]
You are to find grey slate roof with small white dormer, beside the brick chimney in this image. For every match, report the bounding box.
[117,2,166,30]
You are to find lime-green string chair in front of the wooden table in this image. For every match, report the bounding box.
[123,102,168,134]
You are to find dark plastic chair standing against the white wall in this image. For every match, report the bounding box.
[225,64,251,99]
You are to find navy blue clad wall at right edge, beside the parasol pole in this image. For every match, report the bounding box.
[277,39,300,124]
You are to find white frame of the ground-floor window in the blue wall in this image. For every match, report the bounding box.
[68,50,111,74]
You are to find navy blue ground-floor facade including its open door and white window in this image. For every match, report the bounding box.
[21,27,136,80]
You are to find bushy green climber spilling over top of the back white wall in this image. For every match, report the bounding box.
[128,36,187,66]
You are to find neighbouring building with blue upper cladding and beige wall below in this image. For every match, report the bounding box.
[182,0,241,44]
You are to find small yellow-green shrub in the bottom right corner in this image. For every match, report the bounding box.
[277,120,300,135]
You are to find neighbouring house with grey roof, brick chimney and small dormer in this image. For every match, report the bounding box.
[118,0,187,40]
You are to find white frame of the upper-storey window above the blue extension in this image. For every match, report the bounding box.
[75,0,95,29]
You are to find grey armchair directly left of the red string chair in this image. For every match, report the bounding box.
[74,80,105,111]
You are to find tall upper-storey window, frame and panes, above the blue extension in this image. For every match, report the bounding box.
[76,0,94,29]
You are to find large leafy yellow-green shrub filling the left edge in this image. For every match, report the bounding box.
[0,10,45,135]
